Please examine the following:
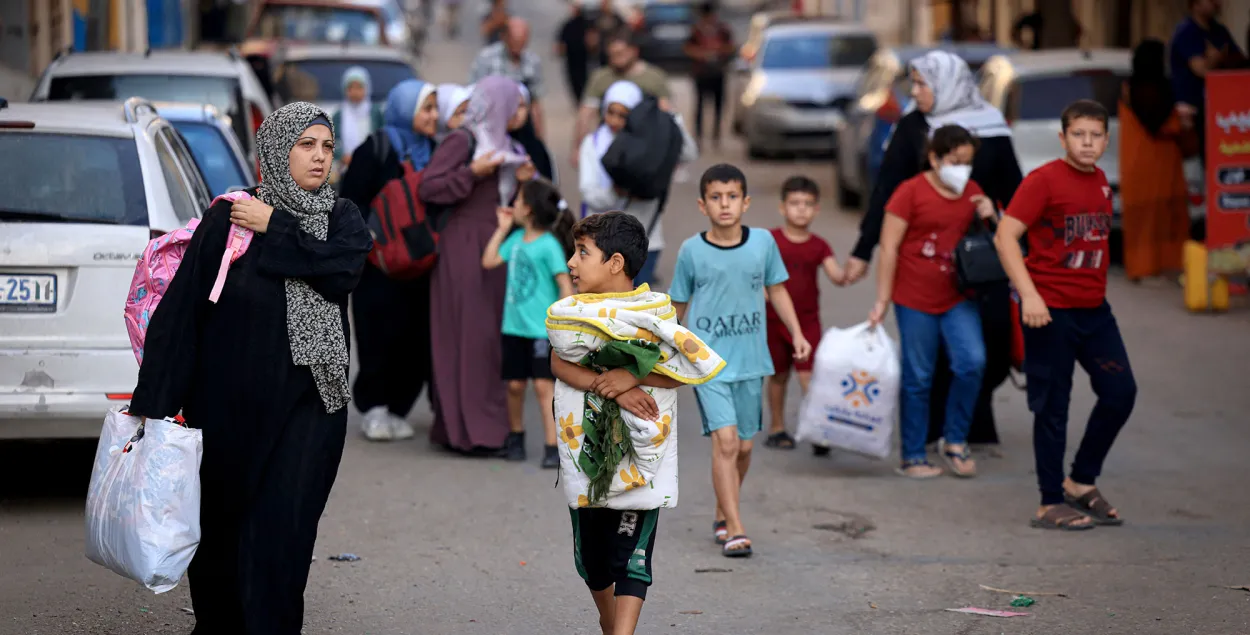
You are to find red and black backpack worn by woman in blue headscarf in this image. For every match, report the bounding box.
[368,130,474,280]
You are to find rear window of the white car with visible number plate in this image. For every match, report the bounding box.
[0,133,148,226]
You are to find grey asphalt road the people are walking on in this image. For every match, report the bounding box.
[0,0,1250,635]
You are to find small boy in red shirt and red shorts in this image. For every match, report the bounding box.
[765,176,846,456]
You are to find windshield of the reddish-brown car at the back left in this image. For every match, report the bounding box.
[254,5,383,45]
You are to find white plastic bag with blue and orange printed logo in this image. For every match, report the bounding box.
[795,323,900,459]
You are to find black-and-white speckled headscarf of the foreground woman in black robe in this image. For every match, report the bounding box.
[256,101,351,413]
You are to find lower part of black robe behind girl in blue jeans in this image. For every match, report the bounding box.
[929,283,1011,444]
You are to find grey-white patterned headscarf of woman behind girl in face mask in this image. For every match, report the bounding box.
[911,51,1011,138]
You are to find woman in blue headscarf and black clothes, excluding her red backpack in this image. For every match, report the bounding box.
[341,79,439,441]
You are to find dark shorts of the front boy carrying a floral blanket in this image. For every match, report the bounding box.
[569,508,660,600]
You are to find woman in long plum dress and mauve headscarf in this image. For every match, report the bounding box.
[419,76,535,456]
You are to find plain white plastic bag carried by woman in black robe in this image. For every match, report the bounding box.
[86,410,204,593]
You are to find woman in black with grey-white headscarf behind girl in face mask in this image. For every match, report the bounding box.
[846,51,1021,445]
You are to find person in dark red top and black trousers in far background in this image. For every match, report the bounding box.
[685,3,735,144]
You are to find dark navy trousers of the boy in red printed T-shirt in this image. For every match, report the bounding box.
[1024,301,1138,505]
